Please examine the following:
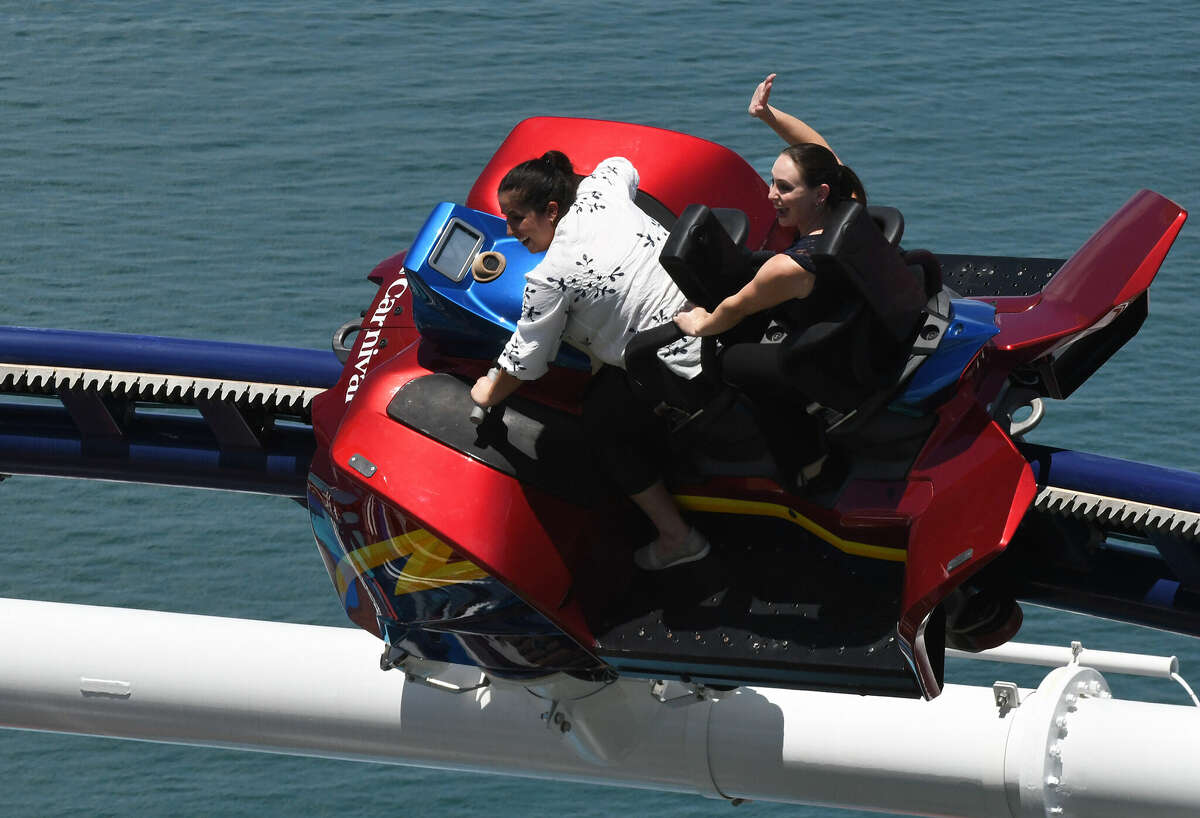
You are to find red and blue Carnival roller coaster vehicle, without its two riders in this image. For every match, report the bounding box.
[308,118,1200,698]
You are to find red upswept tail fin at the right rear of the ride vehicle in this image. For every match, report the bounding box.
[992,191,1188,354]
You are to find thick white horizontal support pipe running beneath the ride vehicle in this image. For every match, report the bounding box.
[0,592,1200,818]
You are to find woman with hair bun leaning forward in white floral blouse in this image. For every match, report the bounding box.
[470,151,709,571]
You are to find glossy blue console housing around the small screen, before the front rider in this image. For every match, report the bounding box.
[404,202,590,369]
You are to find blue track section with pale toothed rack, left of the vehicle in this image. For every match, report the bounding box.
[0,327,342,498]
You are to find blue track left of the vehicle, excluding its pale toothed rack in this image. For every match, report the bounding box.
[0,326,342,499]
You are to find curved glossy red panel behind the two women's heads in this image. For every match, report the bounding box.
[467,116,775,247]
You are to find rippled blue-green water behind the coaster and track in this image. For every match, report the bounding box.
[0,0,1200,816]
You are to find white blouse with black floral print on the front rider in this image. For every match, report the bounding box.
[499,156,700,380]
